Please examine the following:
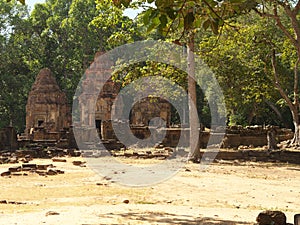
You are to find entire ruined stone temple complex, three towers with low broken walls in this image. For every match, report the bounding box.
[13,54,290,153]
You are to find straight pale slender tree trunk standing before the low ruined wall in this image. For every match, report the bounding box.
[187,33,200,162]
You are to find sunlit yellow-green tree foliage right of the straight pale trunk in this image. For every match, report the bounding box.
[199,13,293,126]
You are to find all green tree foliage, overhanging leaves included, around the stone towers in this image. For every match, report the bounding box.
[0,0,299,132]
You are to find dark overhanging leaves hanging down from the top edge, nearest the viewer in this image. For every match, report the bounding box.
[113,0,258,37]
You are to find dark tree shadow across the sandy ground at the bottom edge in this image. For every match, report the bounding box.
[99,211,253,225]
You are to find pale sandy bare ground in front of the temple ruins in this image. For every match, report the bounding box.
[0,158,300,225]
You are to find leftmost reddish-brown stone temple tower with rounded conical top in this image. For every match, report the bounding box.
[25,68,71,140]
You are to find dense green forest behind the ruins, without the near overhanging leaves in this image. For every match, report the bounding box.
[0,0,297,132]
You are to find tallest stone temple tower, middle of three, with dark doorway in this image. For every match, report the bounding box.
[76,53,122,139]
